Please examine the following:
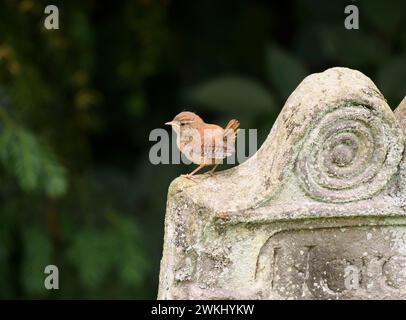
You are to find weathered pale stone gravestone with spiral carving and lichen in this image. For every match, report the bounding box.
[158,68,406,299]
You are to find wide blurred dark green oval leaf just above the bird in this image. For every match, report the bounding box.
[188,76,275,115]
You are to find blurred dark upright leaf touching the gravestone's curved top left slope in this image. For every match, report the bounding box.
[266,46,308,100]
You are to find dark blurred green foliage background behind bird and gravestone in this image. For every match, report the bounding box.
[0,0,406,298]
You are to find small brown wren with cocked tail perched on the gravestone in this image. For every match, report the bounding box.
[165,111,240,178]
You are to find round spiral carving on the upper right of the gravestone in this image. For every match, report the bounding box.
[296,105,403,202]
